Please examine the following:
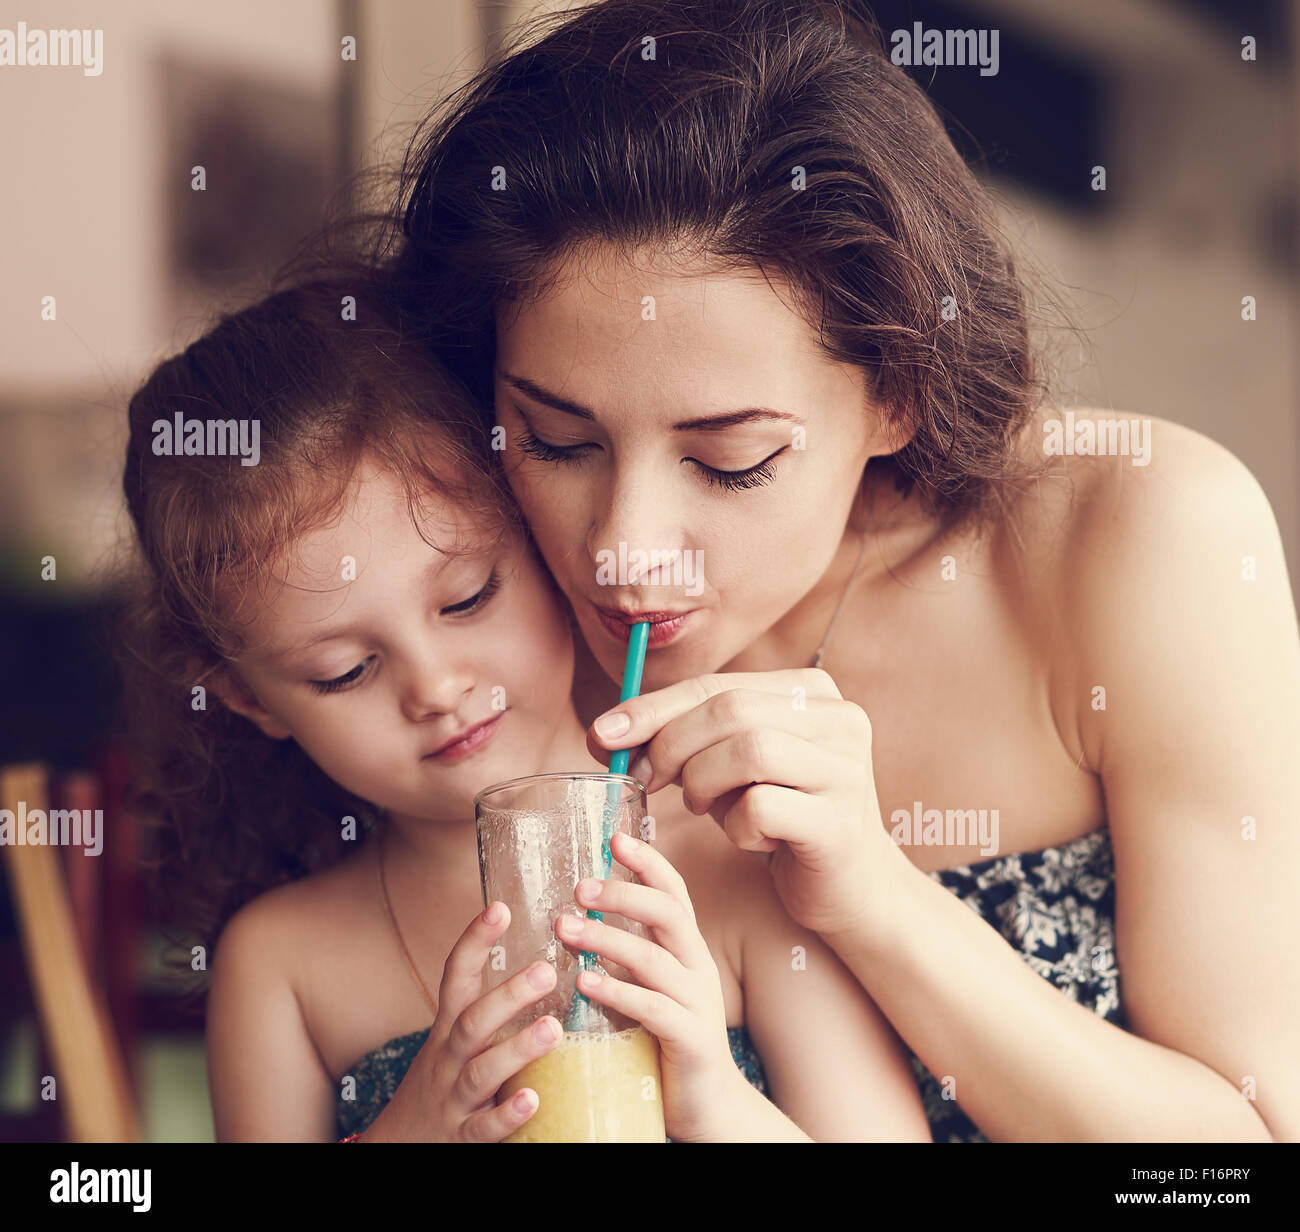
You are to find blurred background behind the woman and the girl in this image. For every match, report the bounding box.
[0,0,1300,1141]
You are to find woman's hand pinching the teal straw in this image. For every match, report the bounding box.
[588,668,911,936]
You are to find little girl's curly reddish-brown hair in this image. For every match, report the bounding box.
[121,269,523,992]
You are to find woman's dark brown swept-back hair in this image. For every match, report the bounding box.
[398,0,1066,532]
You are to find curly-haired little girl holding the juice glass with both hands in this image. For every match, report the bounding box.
[124,276,930,1141]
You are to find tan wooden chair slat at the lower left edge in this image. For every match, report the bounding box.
[0,764,140,1142]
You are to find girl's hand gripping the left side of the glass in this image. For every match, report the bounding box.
[363,902,563,1142]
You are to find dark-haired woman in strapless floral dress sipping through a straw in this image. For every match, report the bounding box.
[387,0,1300,1141]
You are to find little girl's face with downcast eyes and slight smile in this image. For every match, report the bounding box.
[228,464,576,820]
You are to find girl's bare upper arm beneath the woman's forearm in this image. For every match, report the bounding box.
[735,853,931,1142]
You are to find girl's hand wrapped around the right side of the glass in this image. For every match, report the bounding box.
[555,832,744,1142]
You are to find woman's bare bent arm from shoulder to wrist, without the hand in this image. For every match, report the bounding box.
[827,424,1300,1141]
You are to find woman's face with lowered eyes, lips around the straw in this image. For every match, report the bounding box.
[495,250,893,689]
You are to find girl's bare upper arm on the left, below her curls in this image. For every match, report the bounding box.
[207,892,337,1142]
